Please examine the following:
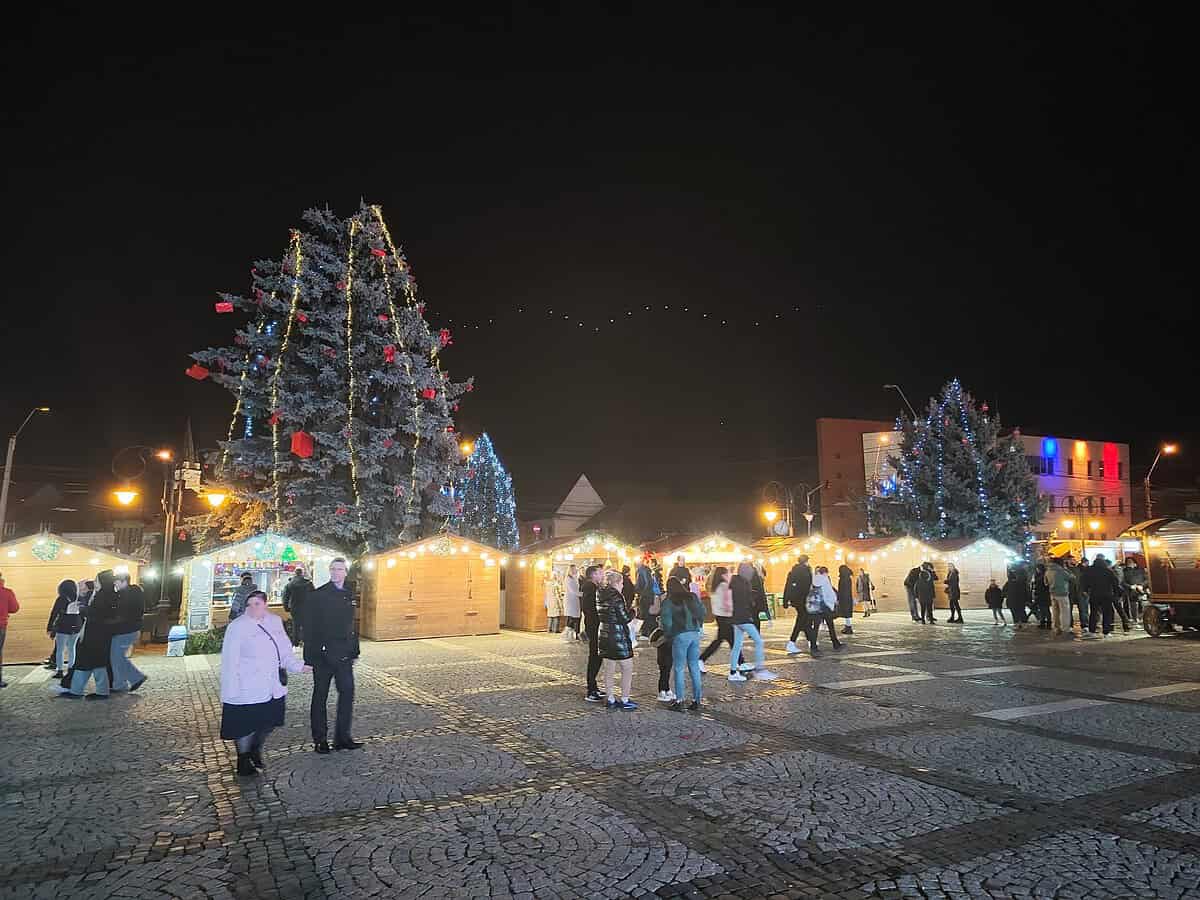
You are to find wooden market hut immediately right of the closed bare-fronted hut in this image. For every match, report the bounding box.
[504,532,642,631]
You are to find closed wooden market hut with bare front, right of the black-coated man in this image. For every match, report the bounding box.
[360,534,509,641]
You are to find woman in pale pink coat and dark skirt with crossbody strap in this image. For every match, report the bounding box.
[221,590,312,775]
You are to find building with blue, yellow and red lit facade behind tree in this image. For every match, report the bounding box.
[817,419,1133,541]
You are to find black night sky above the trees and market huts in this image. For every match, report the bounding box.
[0,4,1200,518]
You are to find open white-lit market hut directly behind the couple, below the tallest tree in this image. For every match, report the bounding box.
[178,532,343,634]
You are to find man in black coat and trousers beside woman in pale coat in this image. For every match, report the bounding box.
[304,557,362,754]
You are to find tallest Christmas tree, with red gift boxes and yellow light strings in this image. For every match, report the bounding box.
[188,205,472,552]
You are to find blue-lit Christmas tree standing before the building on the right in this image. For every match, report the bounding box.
[872,379,1045,546]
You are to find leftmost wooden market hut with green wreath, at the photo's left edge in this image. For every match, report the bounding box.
[0,533,142,664]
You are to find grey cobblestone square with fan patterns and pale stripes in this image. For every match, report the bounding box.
[0,611,1200,900]
